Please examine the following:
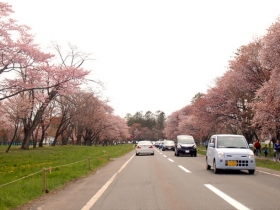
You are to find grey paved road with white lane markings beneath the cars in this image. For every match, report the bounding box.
[17,150,280,210]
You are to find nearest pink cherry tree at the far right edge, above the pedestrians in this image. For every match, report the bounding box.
[252,17,280,140]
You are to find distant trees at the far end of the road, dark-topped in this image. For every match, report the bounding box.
[125,111,166,140]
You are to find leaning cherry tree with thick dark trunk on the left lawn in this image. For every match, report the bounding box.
[18,44,89,149]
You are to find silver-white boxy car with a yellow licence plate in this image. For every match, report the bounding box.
[206,134,256,174]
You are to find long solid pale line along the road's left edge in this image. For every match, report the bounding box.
[81,155,135,210]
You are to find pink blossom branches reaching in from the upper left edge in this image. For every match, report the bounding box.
[0,2,53,100]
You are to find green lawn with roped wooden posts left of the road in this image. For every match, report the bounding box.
[0,144,134,210]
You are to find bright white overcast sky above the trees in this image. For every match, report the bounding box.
[6,0,280,117]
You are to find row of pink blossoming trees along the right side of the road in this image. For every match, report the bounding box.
[165,18,280,142]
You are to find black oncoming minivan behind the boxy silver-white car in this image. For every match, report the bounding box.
[174,135,196,157]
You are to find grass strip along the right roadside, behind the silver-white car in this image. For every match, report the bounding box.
[197,146,280,171]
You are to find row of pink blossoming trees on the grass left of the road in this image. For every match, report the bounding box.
[0,2,129,149]
